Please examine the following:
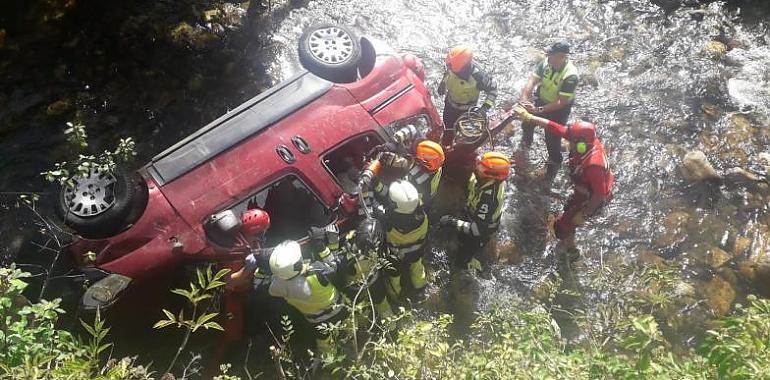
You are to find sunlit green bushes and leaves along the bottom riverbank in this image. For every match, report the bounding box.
[0,258,770,380]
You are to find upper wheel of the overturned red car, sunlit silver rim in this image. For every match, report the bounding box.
[299,25,361,83]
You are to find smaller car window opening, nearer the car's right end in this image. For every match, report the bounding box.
[322,132,383,193]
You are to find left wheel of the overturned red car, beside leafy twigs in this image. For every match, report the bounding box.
[57,169,138,239]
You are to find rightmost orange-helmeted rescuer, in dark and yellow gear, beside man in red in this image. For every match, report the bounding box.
[439,152,511,269]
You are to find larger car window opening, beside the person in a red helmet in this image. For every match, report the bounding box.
[233,175,334,247]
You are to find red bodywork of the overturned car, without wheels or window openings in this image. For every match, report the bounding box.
[69,40,442,307]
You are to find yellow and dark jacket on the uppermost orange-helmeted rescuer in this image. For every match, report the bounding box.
[439,64,497,109]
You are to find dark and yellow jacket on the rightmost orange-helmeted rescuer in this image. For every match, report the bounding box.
[457,173,505,238]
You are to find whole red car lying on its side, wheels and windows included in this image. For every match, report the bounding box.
[58,25,442,310]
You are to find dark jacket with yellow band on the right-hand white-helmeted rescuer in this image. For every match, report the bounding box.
[385,206,428,259]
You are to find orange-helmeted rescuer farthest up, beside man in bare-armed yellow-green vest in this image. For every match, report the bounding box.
[438,46,497,146]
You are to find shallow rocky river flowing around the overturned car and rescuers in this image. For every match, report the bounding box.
[0,0,770,374]
